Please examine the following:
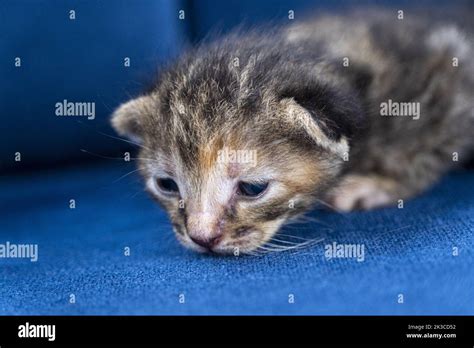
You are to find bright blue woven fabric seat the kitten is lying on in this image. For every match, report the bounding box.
[0,161,474,315]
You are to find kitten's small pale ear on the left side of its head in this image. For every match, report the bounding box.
[111,96,152,143]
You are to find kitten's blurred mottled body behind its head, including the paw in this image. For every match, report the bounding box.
[289,11,474,210]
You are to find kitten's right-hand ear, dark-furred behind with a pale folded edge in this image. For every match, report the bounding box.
[280,87,364,159]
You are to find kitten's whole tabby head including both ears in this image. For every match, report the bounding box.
[112,50,362,254]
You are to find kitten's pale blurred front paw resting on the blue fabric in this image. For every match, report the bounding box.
[329,175,397,212]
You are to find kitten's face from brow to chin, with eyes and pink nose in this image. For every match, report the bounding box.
[140,129,334,254]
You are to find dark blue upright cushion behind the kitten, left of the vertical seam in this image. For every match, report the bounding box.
[0,0,187,170]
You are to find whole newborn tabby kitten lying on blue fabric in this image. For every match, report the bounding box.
[112,11,474,253]
